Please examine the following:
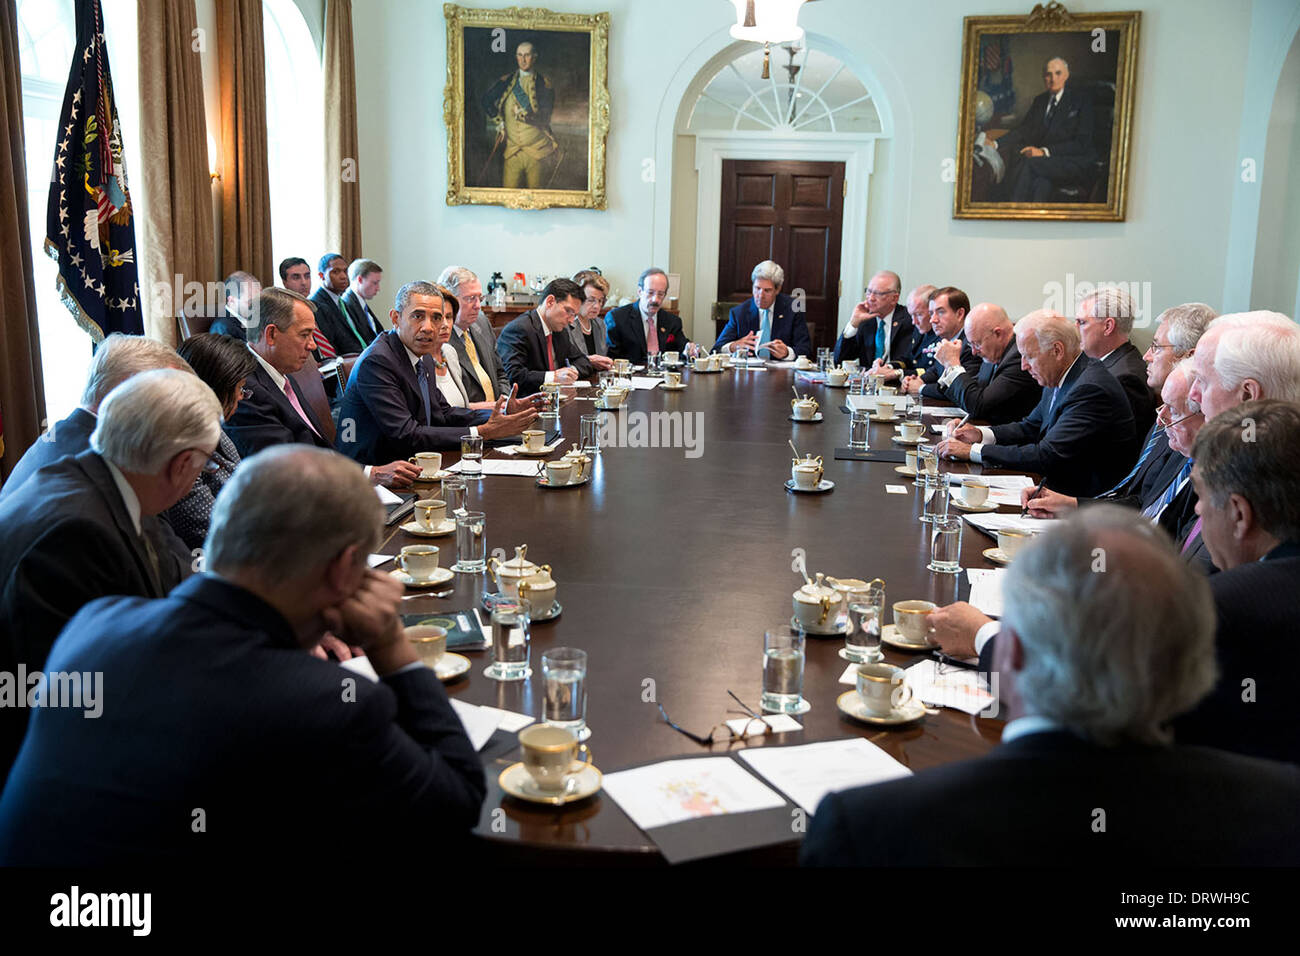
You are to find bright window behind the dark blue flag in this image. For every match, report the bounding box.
[18,0,140,421]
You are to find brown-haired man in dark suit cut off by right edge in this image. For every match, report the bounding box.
[1174,401,1300,763]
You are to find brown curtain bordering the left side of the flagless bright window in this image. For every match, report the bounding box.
[217,0,276,285]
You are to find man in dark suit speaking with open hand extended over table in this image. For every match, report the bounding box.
[335,281,537,464]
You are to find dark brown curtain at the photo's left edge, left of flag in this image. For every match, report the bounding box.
[0,0,46,477]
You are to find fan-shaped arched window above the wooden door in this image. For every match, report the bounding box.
[686,44,880,134]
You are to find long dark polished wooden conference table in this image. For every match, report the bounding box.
[381,368,1002,865]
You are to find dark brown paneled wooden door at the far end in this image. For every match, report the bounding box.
[718,160,844,349]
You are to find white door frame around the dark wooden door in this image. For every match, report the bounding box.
[690,130,885,342]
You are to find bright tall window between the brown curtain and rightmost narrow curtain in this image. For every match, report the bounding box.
[261,0,326,281]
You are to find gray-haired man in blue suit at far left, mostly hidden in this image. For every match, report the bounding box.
[0,332,192,501]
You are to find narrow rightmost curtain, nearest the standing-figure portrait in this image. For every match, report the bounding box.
[325,0,361,260]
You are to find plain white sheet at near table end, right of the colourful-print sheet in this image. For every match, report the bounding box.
[740,737,911,814]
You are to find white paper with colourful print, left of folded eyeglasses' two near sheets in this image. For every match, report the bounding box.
[605,757,785,830]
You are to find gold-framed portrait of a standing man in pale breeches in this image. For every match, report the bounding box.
[442,4,610,209]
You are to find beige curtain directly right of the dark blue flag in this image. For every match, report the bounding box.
[138,0,217,346]
